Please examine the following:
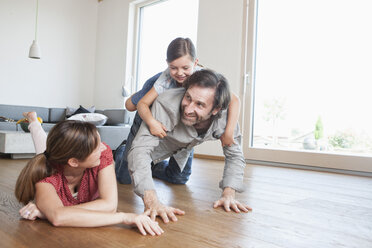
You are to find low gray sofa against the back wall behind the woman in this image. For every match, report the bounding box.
[0,104,134,153]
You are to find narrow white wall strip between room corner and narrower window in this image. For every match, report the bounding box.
[94,0,130,108]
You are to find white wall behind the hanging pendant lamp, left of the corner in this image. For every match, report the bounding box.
[0,0,98,107]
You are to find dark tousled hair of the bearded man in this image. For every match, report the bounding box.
[183,69,231,113]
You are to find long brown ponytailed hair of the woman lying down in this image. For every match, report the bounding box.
[15,120,99,204]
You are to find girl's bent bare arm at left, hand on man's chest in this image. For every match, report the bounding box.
[137,87,167,138]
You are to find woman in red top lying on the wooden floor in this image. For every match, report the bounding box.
[15,112,163,235]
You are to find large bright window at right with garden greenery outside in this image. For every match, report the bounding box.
[246,0,372,171]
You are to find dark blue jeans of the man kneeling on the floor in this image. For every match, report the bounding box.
[115,113,194,184]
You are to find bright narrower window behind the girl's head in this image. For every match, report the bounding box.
[128,0,199,93]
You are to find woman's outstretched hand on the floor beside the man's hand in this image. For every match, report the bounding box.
[124,211,164,236]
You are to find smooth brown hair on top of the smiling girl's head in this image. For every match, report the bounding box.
[167,37,196,63]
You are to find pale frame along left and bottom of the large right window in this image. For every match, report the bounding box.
[242,0,372,175]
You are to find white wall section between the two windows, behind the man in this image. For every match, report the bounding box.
[195,0,244,156]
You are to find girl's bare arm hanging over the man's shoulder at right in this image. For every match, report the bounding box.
[220,93,240,146]
